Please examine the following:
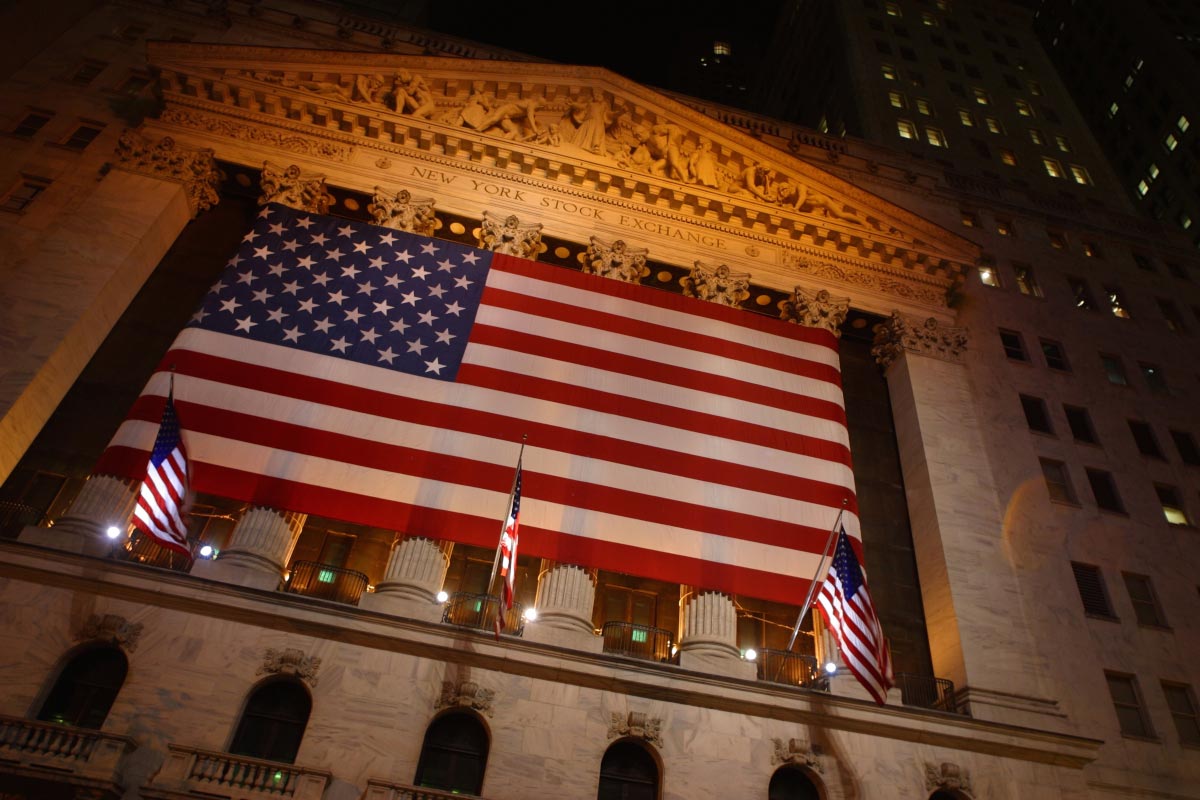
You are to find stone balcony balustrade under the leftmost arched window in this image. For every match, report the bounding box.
[0,715,133,784]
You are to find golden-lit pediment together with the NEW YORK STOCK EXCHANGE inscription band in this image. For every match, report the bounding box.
[144,42,979,318]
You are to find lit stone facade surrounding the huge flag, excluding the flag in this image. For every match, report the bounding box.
[0,2,1200,800]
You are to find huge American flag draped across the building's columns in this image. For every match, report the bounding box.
[97,205,858,603]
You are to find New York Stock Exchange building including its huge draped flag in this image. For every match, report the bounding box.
[0,0,1200,800]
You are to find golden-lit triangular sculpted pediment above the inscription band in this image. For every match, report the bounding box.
[149,42,978,311]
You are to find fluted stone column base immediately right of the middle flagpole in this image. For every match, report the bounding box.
[524,559,604,652]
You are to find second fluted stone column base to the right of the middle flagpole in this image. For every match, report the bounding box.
[679,587,758,680]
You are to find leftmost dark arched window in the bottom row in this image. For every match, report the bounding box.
[37,646,128,730]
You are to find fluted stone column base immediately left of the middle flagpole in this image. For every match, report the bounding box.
[359,536,454,622]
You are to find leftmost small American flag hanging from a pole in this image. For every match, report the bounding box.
[133,390,191,555]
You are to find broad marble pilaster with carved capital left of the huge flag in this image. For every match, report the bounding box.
[0,133,220,481]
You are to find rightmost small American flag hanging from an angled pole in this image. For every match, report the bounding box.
[817,528,894,705]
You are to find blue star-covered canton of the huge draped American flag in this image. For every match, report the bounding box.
[188,204,492,380]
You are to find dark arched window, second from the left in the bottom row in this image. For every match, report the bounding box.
[229,679,312,764]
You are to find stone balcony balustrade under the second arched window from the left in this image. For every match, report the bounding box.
[150,745,330,800]
